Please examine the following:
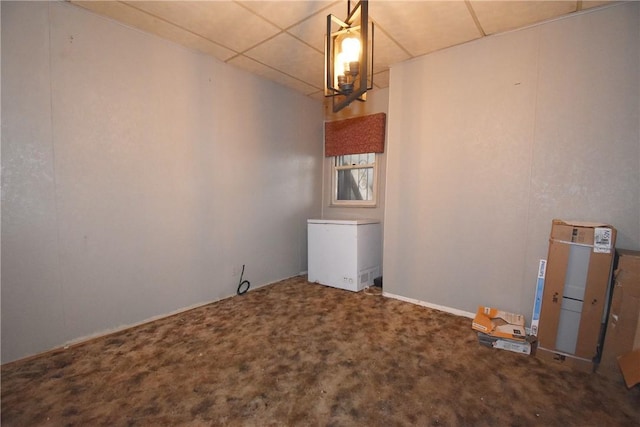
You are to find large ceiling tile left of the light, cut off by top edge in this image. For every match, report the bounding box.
[122,1,280,52]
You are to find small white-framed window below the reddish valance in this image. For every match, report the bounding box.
[332,153,377,206]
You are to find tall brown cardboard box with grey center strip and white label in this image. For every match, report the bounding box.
[538,220,616,364]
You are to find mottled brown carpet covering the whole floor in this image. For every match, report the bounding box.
[1,277,640,426]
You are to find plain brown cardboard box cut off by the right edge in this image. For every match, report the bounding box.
[598,249,640,376]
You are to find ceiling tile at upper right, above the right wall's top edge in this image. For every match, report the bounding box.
[471,0,578,35]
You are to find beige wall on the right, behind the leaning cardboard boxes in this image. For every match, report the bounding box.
[384,2,640,319]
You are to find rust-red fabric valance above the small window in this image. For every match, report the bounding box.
[324,113,387,157]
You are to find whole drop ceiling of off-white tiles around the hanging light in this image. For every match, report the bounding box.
[71,0,609,99]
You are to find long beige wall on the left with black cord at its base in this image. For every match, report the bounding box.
[1,2,322,362]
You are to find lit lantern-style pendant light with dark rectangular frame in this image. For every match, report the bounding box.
[324,0,373,113]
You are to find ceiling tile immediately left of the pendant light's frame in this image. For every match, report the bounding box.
[245,33,324,89]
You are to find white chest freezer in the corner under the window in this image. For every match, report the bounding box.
[307,219,382,292]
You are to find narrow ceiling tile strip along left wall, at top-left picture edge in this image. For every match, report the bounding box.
[72,1,235,61]
